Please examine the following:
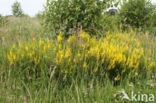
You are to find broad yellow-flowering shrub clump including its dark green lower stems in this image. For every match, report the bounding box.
[6,31,155,81]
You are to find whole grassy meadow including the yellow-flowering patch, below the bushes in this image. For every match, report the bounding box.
[0,16,156,103]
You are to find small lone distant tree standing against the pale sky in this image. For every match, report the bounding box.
[12,1,24,17]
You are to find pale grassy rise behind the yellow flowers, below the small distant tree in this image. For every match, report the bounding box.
[0,17,41,46]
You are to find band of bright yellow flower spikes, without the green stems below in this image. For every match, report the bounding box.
[6,31,152,80]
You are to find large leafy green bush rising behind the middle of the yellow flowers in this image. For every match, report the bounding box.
[42,0,114,36]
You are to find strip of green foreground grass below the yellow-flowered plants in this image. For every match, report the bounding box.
[0,74,156,103]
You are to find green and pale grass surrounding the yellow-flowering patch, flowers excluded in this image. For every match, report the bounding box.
[0,17,156,103]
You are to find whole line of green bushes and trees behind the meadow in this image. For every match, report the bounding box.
[0,0,156,37]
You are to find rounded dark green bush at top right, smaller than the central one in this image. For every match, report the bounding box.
[120,0,153,28]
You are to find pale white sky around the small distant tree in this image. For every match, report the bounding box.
[0,0,156,17]
